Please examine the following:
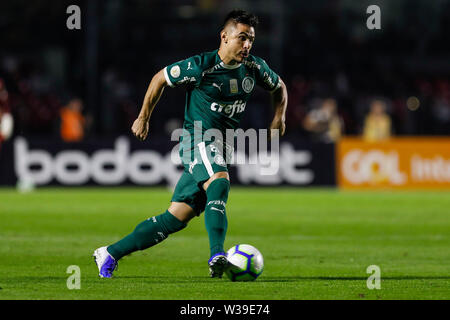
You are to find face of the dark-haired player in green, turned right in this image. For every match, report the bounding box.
[227,23,255,62]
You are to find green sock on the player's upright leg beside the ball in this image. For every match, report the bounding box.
[205,178,230,256]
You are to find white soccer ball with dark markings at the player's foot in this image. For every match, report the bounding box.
[225,244,264,281]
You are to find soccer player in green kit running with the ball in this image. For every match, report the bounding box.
[93,10,287,278]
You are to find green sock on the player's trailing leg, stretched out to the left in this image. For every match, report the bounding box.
[107,211,186,261]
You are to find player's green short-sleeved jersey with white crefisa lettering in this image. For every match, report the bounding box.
[164,50,280,162]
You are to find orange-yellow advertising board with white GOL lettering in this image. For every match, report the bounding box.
[336,137,450,189]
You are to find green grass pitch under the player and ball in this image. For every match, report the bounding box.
[0,187,450,300]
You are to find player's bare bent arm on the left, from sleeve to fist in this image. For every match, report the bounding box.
[131,69,167,140]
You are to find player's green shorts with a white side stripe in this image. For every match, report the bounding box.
[171,142,228,216]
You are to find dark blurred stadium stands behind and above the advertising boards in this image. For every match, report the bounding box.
[0,0,450,140]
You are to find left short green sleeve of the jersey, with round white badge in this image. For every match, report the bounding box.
[164,55,203,87]
